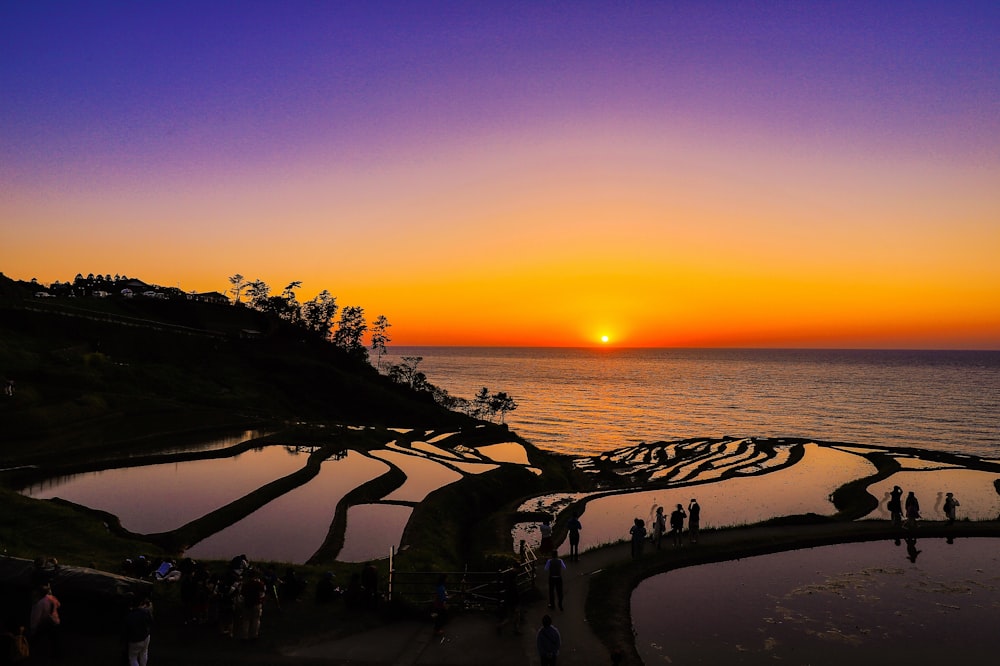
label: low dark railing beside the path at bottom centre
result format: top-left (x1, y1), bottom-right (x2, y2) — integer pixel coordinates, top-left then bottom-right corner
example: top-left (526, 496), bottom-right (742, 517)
top-left (387, 548), bottom-right (537, 610)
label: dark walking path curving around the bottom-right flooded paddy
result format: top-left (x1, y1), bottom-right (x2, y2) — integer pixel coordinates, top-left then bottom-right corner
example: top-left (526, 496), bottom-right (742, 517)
top-left (285, 521), bottom-right (1000, 666)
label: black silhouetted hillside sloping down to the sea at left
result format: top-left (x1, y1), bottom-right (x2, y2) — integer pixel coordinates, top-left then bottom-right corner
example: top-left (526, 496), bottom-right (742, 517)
top-left (0, 275), bottom-right (468, 465)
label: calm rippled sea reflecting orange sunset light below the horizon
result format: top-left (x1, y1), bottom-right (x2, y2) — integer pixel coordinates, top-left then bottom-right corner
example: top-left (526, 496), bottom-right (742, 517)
top-left (389, 347), bottom-right (1000, 457)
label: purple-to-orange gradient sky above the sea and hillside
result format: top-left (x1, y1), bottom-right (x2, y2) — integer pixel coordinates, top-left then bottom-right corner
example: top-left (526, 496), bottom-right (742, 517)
top-left (0, 0), bottom-right (1000, 349)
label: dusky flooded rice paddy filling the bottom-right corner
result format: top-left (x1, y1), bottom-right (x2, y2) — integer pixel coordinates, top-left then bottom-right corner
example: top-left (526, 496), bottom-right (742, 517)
top-left (631, 539), bottom-right (1000, 666)
